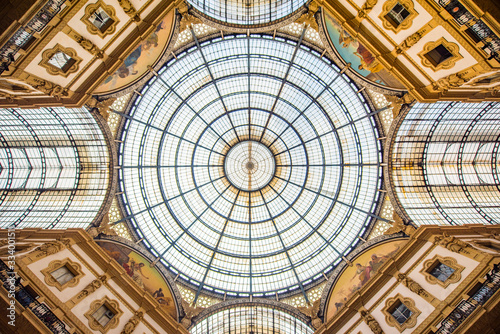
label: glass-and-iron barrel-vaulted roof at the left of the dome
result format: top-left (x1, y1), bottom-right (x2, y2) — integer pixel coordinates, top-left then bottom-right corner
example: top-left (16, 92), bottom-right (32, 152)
top-left (0, 108), bottom-right (109, 228)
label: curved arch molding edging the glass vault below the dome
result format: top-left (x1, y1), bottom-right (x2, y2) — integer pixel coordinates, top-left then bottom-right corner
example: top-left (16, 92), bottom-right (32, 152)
top-left (190, 298), bottom-right (312, 328)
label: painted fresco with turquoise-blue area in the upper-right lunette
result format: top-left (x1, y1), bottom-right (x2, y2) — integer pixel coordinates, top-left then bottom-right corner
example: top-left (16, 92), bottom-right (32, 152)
top-left (324, 13), bottom-right (405, 89)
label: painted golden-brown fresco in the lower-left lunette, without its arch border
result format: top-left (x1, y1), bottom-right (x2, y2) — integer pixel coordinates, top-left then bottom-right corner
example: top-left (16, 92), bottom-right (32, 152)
top-left (97, 241), bottom-right (177, 319)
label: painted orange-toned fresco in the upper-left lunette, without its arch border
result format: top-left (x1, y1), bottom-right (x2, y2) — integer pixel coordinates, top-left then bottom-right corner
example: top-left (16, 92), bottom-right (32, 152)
top-left (94, 11), bottom-right (174, 94)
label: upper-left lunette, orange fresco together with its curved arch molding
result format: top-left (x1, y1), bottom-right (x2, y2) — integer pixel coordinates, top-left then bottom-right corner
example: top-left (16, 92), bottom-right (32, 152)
top-left (94, 9), bottom-right (179, 97)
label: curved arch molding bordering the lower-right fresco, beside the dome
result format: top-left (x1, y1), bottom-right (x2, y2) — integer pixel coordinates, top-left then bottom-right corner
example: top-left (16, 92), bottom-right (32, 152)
top-left (318, 232), bottom-right (408, 322)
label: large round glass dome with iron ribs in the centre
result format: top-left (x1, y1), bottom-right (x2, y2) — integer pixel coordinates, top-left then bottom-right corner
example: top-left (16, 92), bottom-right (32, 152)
top-left (120, 35), bottom-right (381, 296)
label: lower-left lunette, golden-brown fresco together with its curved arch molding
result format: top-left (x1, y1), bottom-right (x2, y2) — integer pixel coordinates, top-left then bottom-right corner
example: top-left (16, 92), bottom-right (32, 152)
top-left (95, 235), bottom-right (183, 321)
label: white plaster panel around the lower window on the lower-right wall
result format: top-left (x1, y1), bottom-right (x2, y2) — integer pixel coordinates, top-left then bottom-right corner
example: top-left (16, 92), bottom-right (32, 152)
top-left (372, 284), bottom-right (434, 334)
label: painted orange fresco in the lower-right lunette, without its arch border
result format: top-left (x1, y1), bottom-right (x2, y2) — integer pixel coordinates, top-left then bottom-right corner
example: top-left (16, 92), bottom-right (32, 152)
top-left (326, 240), bottom-right (407, 320)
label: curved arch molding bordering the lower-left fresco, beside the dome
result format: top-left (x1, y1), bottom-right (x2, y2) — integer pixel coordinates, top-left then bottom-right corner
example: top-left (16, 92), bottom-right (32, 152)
top-left (94, 234), bottom-right (184, 321)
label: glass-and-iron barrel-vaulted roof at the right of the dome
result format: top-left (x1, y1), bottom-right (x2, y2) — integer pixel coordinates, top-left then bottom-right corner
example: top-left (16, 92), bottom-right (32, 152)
top-left (392, 102), bottom-right (500, 225)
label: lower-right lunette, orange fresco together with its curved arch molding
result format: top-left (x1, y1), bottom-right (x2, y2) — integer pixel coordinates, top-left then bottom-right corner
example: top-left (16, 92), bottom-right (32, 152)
top-left (322, 234), bottom-right (408, 323)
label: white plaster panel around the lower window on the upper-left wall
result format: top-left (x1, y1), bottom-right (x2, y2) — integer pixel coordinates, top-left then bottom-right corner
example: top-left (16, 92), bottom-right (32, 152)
top-left (25, 32), bottom-right (93, 87)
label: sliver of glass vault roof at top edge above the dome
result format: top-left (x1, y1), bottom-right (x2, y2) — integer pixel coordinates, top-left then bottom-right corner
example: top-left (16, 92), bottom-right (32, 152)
top-left (187, 0), bottom-right (307, 25)
